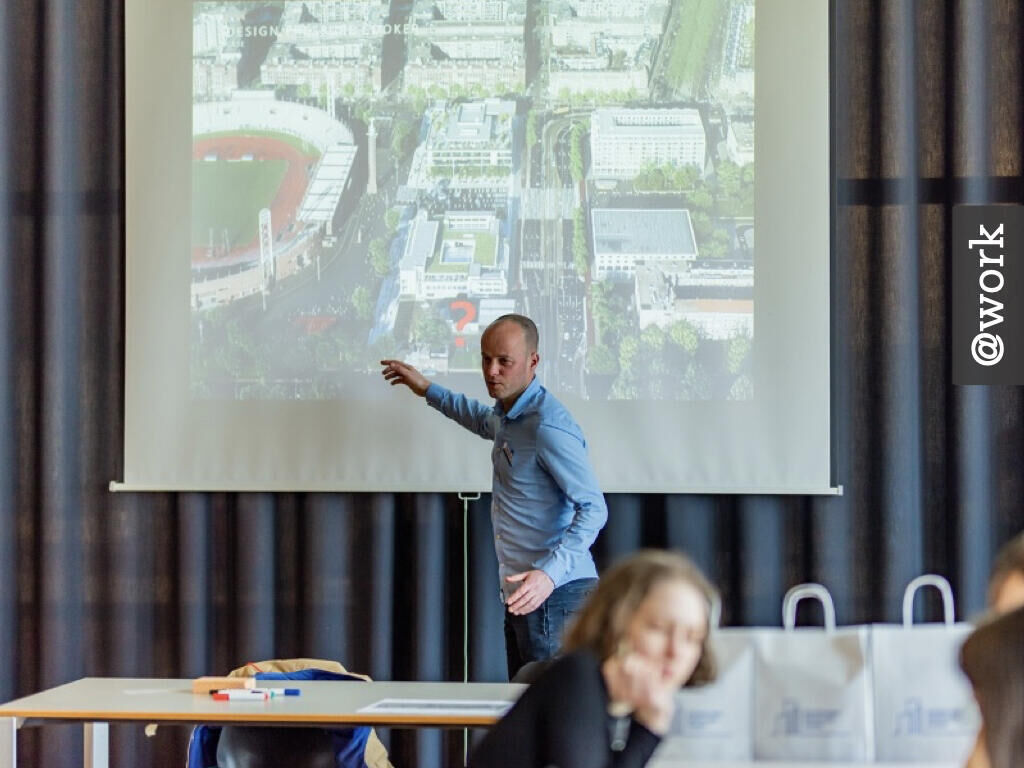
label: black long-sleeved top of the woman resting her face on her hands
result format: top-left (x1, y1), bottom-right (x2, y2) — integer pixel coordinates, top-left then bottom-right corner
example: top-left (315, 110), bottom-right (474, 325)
top-left (469, 651), bottom-right (660, 768)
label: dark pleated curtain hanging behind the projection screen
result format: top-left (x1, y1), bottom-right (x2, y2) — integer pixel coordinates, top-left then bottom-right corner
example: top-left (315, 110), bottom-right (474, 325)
top-left (0, 0), bottom-right (1024, 766)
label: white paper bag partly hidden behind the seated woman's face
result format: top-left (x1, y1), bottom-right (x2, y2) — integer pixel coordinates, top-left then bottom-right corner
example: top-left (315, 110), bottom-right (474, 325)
top-left (655, 629), bottom-right (754, 761)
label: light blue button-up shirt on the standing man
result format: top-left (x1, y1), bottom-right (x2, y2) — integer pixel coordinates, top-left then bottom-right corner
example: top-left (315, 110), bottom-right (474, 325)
top-left (426, 377), bottom-right (608, 598)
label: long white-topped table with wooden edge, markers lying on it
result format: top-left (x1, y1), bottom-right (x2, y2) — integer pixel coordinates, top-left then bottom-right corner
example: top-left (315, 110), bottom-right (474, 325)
top-left (0, 678), bottom-right (525, 768)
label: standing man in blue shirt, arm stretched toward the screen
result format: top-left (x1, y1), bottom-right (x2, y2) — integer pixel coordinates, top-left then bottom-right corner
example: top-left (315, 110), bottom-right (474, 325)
top-left (381, 314), bottom-right (608, 678)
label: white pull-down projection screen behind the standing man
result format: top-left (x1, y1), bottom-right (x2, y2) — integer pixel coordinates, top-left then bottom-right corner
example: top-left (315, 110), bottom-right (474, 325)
top-left (123, 0), bottom-right (833, 494)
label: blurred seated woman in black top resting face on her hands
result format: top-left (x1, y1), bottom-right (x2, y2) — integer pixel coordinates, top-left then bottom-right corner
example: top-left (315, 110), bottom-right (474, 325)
top-left (469, 550), bottom-right (715, 768)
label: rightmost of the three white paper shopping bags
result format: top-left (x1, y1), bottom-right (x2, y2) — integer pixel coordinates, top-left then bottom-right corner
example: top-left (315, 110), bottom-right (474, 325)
top-left (871, 574), bottom-right (979, 764)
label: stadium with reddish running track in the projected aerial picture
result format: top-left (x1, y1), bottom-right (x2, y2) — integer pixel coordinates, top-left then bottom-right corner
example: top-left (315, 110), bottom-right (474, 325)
top-left (191, 91), bottom-right (357, 309)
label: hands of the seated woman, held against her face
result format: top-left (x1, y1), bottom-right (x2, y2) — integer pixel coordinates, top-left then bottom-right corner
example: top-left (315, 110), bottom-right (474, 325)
top-left (601, 652), bottom-right (676, 735)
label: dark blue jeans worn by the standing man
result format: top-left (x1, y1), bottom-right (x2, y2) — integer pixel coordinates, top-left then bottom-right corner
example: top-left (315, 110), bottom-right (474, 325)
top-left (505, 579), bottom-right (597, 680)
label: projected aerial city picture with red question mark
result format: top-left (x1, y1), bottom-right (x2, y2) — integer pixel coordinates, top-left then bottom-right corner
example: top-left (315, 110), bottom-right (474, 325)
top-left (189, 0), bottom-right (755, 400)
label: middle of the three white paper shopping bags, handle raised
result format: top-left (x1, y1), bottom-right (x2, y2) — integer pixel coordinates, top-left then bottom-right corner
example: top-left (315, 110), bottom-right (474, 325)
top-left (754, 584), bottom-right (874, 762)
